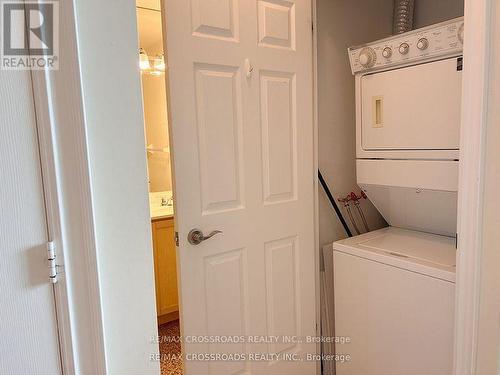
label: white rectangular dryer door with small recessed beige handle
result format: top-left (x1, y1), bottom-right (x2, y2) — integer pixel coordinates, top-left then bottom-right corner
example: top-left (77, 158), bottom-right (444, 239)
top-left (361, 58), bottom-right (462, 151)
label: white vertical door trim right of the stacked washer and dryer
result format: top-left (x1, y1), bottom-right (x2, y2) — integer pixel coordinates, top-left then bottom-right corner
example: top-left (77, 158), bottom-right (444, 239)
top-left (454, 0), bottom-right (491, 375)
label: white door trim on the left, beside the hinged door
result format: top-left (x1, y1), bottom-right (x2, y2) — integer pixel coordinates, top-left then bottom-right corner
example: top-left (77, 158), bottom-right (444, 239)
top-left (32, 0), bottom-right (106, 375)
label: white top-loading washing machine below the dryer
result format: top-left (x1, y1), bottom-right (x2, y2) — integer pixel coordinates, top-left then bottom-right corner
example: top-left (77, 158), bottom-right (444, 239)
top-left (333, 227), bottom-right (455, 375)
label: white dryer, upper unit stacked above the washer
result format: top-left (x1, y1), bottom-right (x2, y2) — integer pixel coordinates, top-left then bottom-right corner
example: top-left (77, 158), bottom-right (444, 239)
top-left (349, 18), bottom-right (463, 236)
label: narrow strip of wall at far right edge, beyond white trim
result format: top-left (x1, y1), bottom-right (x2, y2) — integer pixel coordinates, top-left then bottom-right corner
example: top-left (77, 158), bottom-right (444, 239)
top-left (476, 2), bottom-right (500, 375)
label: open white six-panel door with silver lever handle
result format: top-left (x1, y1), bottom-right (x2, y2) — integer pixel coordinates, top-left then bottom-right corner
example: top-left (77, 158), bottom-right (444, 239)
top-left (165, 0), bottom-right (316, 375)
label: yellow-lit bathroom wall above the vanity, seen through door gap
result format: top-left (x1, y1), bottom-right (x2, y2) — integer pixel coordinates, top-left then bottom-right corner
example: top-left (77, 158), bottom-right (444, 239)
top-left (137, 8), bottom-right (172, 192)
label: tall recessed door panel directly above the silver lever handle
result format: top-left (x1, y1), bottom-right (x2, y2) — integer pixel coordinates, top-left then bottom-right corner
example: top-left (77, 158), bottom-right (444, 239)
top-left (195, 64), bottom-right (244, 215)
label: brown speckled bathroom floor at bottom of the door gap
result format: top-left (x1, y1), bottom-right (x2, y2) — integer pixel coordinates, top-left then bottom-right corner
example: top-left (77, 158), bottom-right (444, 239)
top-left (158, 320), bottom-right (182, 375)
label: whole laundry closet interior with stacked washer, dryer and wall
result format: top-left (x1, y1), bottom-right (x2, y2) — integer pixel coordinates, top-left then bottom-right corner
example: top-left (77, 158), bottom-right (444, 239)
top-left (317, 0), bottom-right (466, 375)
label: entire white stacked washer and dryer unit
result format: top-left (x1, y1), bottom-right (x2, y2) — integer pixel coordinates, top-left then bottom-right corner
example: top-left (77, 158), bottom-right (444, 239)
top-left (332, 18), bottom-right (463, 375)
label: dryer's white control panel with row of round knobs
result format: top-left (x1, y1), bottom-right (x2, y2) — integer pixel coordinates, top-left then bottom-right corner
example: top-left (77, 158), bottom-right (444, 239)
top-left (348, 17), bottom-right (464, 74)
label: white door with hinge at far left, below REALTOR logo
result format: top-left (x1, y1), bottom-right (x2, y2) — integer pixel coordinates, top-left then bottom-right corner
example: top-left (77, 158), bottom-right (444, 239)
top-left (0, 70), bottom-right (61, 375)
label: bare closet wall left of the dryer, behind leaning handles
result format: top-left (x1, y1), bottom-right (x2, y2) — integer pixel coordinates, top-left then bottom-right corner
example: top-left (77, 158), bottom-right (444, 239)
top-left (317, 0), bottom-right (393, 245)
